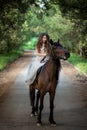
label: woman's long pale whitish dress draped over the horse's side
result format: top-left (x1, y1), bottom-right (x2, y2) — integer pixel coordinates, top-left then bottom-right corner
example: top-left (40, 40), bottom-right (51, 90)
top-left (26, 47), bottom-right (46, 85)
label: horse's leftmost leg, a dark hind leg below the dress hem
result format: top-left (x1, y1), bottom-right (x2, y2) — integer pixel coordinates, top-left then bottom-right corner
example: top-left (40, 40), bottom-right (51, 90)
top-left (29, 85), bottom-right (35, 116)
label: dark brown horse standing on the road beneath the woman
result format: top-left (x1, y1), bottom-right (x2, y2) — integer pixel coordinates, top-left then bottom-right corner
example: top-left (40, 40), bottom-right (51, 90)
top-left (29, 39), bottom-right (70, 126)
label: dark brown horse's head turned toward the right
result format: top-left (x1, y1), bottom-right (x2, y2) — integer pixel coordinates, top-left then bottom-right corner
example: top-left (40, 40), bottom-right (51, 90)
top-left (52, 40), bottom-right (70, 60)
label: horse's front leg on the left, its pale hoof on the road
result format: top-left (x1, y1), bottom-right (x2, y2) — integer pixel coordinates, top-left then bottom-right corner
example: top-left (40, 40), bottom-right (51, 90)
top-left (37, 95), bottom-right (44, 126)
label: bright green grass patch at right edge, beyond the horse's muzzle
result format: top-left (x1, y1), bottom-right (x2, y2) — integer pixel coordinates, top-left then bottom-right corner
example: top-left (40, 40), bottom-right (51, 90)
top-left (68, 53), bottom-right (87, 74)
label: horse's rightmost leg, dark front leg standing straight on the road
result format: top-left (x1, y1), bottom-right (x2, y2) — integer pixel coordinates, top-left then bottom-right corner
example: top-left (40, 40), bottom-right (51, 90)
top-left (49, 92), bottom-right (56, 126)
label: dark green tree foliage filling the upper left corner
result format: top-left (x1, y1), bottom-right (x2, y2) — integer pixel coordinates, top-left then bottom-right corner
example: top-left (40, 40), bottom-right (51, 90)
top-left (0, 0), bottom-right (34, 54)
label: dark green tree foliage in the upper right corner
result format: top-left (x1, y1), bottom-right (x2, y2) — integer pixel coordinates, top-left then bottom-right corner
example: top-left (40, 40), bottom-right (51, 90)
top-left (55, 0), bottom-right (87, 58)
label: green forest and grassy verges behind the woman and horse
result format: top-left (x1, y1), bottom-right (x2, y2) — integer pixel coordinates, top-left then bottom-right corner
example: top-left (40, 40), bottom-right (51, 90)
top-left (0, 0), bottom-right (87, 73)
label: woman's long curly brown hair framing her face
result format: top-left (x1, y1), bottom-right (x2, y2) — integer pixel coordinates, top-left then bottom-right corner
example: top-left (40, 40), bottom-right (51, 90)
top-left (36, 33), bottom-right (51, 53)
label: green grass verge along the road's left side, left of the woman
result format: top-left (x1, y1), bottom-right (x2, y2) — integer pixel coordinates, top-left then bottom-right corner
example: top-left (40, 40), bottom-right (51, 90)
top-left (0, 37), bottom-right (37, 70)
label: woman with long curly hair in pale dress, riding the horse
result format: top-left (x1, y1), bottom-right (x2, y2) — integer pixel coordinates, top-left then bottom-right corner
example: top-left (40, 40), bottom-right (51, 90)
top-left (26, 33), bottom-right (51, 85)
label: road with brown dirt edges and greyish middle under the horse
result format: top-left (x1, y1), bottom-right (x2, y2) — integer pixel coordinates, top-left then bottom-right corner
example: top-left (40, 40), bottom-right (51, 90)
top-left (0, 52), bottom-right (87, 130)
